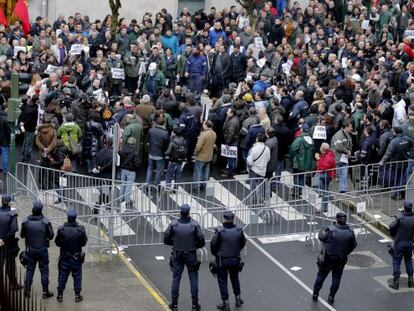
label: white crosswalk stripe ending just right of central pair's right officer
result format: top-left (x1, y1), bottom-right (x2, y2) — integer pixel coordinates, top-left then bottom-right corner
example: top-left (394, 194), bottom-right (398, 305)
top-left (207, 178), bottom-right (264, 225)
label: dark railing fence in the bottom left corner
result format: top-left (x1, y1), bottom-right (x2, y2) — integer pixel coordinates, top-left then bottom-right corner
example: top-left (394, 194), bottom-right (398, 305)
top-left (0, 246), bottom-right (46, 311)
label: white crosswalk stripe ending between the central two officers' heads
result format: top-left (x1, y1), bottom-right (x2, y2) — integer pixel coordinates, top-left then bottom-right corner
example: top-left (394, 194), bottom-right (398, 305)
top-left (169, 186), bottom-right (221, 228)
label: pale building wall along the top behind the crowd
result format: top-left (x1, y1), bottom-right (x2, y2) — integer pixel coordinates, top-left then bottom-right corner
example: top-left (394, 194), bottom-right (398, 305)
top-left (29, 0), bottom-right (309, 21)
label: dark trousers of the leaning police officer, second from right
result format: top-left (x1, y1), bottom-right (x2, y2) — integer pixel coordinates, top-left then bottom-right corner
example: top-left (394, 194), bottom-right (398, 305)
top-left (314, 254), bottom-right (348, 297)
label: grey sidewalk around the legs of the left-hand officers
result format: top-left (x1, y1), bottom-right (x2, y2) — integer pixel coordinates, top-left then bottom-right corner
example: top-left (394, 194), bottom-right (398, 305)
top-left (27, 246), bottom-right (166, 311)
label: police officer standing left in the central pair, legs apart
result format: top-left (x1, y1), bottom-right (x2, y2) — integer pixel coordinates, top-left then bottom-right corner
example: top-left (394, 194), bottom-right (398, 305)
top-left (164, 204), bottom-right (205, 311)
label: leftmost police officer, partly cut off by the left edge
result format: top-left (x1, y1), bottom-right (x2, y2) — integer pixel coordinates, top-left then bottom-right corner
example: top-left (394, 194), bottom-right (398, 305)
top-left (0, 194), bottom-right (21, 289)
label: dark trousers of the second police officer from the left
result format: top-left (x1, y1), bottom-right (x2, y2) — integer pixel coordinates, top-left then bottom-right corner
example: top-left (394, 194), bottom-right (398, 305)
top-left (24, 247), bottom-right (49, 292)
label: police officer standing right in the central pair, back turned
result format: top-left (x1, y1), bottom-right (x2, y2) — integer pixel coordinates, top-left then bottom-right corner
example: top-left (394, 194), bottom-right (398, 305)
top-left (210, 211), bottom-right (246, 311)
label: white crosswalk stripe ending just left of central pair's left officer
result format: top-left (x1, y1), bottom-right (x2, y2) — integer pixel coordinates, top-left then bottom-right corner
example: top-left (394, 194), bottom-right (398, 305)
top-left (131, 185), bottom-right (171, 232)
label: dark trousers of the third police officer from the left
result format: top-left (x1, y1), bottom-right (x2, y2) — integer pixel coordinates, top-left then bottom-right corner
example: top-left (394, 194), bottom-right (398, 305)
top-left (58, 256), bottom-right (82, 295)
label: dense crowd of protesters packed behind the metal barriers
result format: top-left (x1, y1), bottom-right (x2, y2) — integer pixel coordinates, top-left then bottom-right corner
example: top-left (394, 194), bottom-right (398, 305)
top-left (0, 0), bottom-right (414, 200)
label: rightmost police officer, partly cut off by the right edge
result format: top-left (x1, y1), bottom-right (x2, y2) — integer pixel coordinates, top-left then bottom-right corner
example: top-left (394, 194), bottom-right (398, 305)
top-left (389, 200), bottom-right (414, 290)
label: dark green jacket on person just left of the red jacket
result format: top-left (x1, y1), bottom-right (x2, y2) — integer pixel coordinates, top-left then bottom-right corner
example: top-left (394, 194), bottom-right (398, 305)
top-left (289, 133), bottom-right (316, 172)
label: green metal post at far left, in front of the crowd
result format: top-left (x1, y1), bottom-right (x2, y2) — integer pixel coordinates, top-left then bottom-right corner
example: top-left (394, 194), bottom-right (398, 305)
top-left (7, 72), bottom-right (20, 175)
